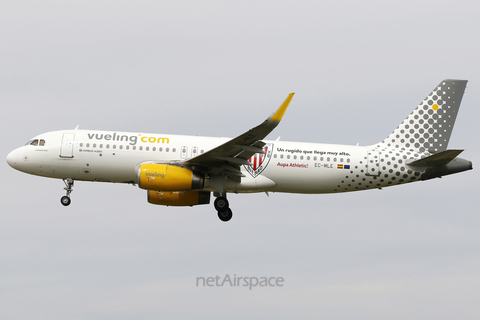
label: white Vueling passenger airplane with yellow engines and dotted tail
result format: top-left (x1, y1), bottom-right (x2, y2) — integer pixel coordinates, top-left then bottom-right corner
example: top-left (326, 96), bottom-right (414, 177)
top-left (6, 80), bottom-right (473, 221)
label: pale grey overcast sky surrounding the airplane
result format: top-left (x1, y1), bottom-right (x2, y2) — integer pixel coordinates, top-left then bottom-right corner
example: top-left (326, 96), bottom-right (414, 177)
top-left (0, 0), bottom-right (480, 320)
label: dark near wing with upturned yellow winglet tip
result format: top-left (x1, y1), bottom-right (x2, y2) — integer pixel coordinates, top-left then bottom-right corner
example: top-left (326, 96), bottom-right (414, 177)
top-left (182, 93), bottom-right (294, 177)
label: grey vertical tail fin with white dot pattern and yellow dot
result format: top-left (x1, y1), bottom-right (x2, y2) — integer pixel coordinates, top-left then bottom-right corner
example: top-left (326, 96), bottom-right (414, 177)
top-left (377, 79), bottom-right (467, 153)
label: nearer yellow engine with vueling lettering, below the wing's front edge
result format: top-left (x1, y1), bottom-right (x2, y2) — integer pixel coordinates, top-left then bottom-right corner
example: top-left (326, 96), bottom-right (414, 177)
top-left (137, 163), bottom-right (205, 191)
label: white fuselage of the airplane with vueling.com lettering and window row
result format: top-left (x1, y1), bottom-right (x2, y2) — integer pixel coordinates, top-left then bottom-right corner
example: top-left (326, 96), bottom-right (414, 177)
top-left (7, 130), bottom-right (423, 193)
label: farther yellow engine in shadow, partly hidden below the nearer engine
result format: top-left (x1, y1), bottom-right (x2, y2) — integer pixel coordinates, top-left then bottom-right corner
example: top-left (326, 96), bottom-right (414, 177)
top-left (147, 191), bottom-right (210, 206)
